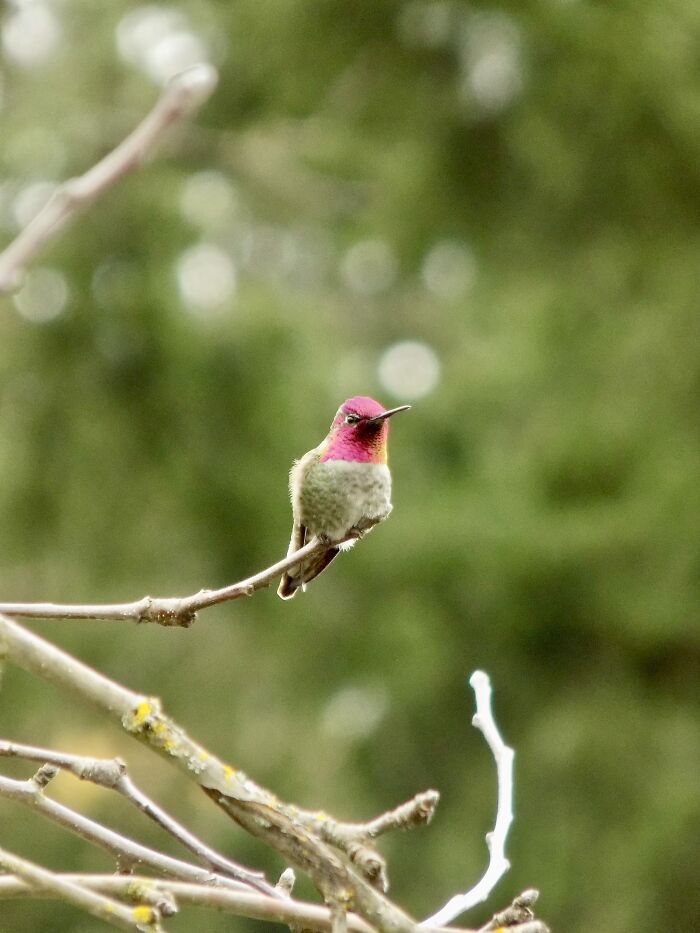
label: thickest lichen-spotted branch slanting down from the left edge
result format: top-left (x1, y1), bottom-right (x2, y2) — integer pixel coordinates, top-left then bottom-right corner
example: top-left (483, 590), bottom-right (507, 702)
top-left (0, 616), bottom-right (416, 933)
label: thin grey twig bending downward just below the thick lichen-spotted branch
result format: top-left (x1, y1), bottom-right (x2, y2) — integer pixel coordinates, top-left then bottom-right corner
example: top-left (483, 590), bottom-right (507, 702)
top-left (0, 740), bottom-right (275, 894)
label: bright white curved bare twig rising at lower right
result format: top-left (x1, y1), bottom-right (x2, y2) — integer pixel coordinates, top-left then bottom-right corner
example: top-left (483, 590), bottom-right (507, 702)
top-left (421, 671), bottom-right (515, 926)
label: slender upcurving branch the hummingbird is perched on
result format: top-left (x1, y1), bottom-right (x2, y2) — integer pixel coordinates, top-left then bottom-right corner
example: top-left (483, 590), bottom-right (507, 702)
top-left (0, 538), bottom-right (344, 627)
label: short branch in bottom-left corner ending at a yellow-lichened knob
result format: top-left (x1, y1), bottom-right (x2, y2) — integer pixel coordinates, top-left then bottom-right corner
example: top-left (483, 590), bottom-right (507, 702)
top-left (0, 849), bottom-right (160, 933)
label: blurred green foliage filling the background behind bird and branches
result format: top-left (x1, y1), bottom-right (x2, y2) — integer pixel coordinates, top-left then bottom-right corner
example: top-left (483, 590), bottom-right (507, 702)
top-left (0, 0), bottom-right (700, 933)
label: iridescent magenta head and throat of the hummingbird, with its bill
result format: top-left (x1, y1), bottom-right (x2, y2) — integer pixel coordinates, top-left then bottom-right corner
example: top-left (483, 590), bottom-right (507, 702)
top-left (321, 395), bottom-right (411, 463)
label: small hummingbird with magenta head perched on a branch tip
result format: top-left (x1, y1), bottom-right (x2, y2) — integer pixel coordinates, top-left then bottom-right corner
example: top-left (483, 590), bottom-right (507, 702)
top-left (277, 395), bottom-right (411, 599)
